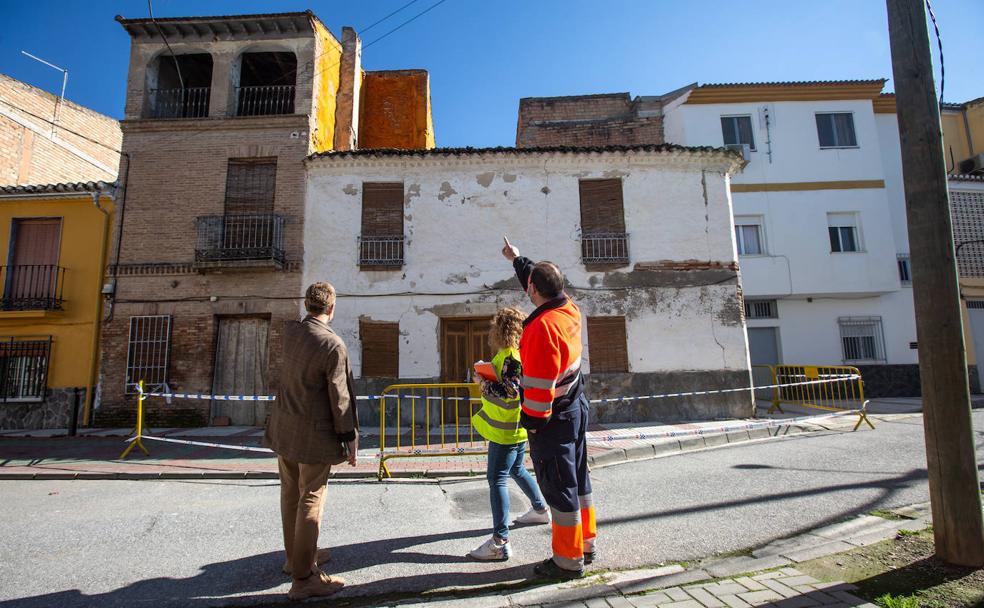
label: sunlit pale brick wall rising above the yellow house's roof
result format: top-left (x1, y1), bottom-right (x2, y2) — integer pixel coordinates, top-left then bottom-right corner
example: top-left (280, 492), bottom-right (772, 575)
top-left (0, 74), bottom-right (122, 185)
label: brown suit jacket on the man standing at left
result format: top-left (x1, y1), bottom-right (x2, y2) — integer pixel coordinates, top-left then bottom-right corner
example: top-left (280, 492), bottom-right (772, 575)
top-left (263, 316), bottom-right (359, 464)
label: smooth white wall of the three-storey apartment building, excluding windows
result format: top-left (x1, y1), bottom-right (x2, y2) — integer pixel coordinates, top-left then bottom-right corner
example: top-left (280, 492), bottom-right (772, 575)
top-left (664, 96), bottom-right (917, 365)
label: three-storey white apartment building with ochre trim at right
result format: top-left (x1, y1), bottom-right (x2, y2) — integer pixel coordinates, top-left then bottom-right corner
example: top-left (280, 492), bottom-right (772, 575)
top-left (662, 80), bottom-right (918, 396)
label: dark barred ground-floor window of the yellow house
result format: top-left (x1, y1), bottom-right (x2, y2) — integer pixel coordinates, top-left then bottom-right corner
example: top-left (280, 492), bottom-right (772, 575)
top-left (0, 336), bottom-right (51, 403)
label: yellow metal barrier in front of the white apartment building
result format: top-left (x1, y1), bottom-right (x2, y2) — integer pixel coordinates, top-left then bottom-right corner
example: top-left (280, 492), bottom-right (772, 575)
top-left (756, 365), bottom-right (875, 431)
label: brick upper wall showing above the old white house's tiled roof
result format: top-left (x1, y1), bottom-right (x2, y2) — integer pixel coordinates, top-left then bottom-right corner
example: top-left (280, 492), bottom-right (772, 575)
top-left (516, 93), bottom-right (664, 148)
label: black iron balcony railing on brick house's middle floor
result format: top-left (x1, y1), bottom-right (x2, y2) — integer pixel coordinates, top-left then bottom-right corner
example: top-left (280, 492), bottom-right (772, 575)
top-left (195, 213), bottom-right (286, 264)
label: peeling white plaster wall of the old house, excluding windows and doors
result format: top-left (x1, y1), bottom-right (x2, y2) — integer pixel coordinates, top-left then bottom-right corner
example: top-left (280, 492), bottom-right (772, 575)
top-left (303, 147), bottom-right (749, 404)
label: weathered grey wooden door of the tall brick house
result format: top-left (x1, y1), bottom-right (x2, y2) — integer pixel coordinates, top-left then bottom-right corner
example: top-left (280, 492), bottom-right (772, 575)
top-left (212, 317), bottom-right (270, 426)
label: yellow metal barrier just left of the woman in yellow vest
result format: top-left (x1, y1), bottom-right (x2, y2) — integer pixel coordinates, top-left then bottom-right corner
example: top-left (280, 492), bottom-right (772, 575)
top-left (377, 382), bottom-right (488, 480)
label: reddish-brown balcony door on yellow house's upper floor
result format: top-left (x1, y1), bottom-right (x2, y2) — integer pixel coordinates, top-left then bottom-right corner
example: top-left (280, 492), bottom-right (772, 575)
top-left (4, 218), bottom-right (61, 307)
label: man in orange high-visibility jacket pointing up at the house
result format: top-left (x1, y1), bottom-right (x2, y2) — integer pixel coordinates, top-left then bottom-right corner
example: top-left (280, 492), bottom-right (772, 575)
top-left (502, 234), bottom-right (597, 579)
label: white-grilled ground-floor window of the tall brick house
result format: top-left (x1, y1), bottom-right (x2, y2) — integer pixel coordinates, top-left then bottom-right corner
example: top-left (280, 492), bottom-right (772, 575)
top-left (126, 315), bottom-right (171, 394)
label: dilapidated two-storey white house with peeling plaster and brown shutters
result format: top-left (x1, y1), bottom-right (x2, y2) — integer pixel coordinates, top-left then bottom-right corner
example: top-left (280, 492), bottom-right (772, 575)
top-left (303, 145), bottom-right (748, 423)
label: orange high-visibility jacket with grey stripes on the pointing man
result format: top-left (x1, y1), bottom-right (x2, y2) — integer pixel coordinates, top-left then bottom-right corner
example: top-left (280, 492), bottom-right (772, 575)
top-left (519, 295), bottom-right (581, 418)
